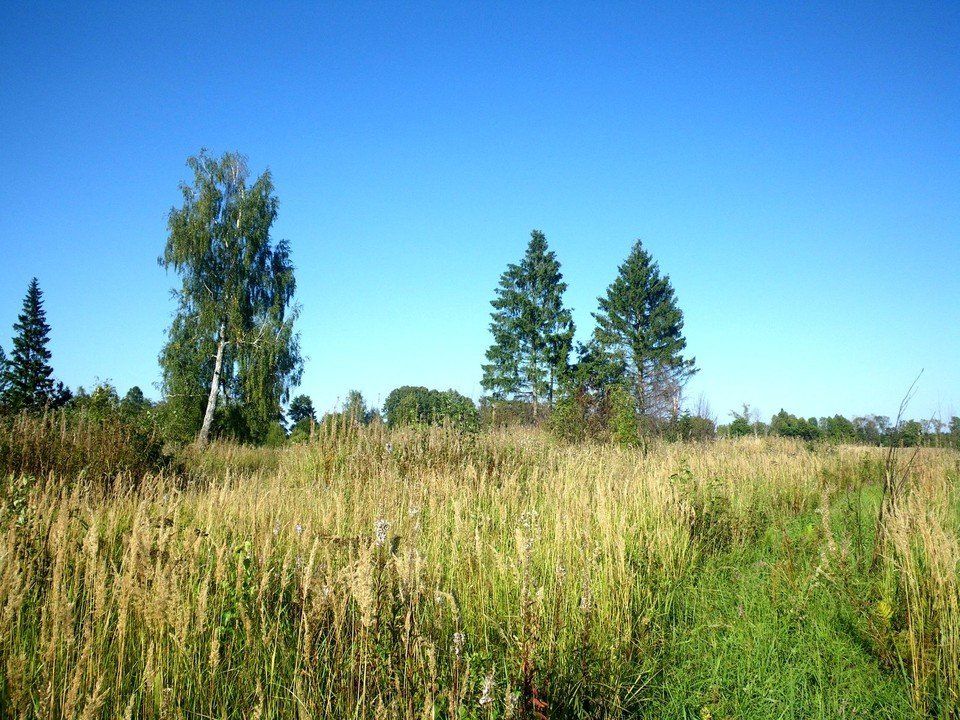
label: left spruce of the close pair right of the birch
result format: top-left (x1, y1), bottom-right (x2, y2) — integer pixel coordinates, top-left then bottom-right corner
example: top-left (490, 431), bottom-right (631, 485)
top-left (481, 230), bottom-right (574, 416)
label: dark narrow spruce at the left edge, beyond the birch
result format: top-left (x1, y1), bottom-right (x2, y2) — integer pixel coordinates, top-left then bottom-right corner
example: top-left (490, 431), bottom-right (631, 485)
top-left (3, 278), bottom-right (62, 411)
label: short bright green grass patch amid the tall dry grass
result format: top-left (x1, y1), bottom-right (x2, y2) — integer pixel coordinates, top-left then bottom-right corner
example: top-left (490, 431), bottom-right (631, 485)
top-left (646, 506), bottom-right (914, 719)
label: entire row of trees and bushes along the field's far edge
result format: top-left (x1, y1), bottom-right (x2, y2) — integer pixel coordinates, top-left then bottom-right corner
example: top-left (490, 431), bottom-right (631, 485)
top-left (0, 151), bottom-right (960, 445)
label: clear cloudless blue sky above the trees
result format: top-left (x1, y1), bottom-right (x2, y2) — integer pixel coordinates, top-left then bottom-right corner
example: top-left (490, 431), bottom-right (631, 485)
top-left (0, 2), bottom-right (960, 420)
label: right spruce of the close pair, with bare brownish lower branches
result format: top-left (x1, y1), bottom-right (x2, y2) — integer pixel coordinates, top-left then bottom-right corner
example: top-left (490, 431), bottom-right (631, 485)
top-left (594, 240), bottom-right (696, 418)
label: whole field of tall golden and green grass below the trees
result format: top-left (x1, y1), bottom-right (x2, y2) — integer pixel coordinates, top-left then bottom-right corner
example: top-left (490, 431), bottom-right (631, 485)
top-left (0, 427), bottom-right (960, 720)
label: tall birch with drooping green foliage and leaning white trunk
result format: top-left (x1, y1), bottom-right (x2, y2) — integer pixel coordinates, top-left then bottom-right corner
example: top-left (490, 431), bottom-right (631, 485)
top-left (160, 152), bottom-right (302, 442)
